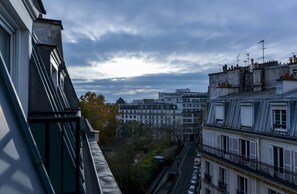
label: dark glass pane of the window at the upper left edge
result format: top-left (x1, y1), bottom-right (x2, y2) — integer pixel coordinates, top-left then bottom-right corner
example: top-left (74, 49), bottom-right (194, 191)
top-left (0, 26), bottom-right (10, 70)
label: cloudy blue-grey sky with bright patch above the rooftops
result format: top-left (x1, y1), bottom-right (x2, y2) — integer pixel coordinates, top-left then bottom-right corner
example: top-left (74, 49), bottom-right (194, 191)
top-left (43, 0), bottom-right (297, 102)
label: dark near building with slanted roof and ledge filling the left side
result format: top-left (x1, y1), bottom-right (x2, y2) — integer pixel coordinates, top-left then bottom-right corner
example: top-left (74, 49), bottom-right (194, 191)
top-left (0, 0), bottom-right (121, 194)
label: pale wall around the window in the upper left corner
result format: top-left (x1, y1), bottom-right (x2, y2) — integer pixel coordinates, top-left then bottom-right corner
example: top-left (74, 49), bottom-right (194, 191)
top-left (0, 0), bottom-right (39, 114)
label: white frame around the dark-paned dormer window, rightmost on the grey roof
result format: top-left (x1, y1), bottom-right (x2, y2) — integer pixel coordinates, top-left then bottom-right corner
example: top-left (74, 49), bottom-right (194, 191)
top-left (270, 103), bottom-right (290, 132)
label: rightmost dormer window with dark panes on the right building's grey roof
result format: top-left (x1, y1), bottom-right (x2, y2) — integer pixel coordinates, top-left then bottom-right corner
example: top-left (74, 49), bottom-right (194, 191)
top-left (271, 103), bottom-right (288, 132)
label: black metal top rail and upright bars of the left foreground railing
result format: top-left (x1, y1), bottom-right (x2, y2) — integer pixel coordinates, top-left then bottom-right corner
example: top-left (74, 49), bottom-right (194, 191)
top-left (28, 110), bottom-right (81, 194)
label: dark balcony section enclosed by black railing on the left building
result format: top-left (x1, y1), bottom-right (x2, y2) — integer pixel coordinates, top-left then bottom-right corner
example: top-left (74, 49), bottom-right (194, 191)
top-left (28, 109), bottom-right (83, 193)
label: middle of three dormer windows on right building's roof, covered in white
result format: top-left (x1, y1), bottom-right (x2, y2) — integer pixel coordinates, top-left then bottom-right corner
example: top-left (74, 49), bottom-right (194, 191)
top-left (240, 103), bottom-right (254, 127)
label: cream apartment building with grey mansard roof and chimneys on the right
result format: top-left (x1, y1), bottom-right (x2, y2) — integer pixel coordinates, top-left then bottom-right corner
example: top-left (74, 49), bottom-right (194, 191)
top-left (198, 56), bottom-right (297, 194)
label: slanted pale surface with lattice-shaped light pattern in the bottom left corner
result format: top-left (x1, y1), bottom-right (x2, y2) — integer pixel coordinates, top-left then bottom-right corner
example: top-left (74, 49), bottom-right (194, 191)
top-left (0, 66), bottom-right (45, 194)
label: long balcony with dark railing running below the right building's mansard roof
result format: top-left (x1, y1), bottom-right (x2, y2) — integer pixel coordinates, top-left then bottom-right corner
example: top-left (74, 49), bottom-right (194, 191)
top-left (198, 144), bottom-right (297, 189)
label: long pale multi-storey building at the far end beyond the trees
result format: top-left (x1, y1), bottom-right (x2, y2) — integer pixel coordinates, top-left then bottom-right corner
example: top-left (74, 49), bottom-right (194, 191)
top-left (117, 89), bottom-right (207, 141)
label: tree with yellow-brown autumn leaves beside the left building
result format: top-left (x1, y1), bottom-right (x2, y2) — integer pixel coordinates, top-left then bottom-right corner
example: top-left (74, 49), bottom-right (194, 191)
top-left (80, 92), bottom-right (118, 145)
